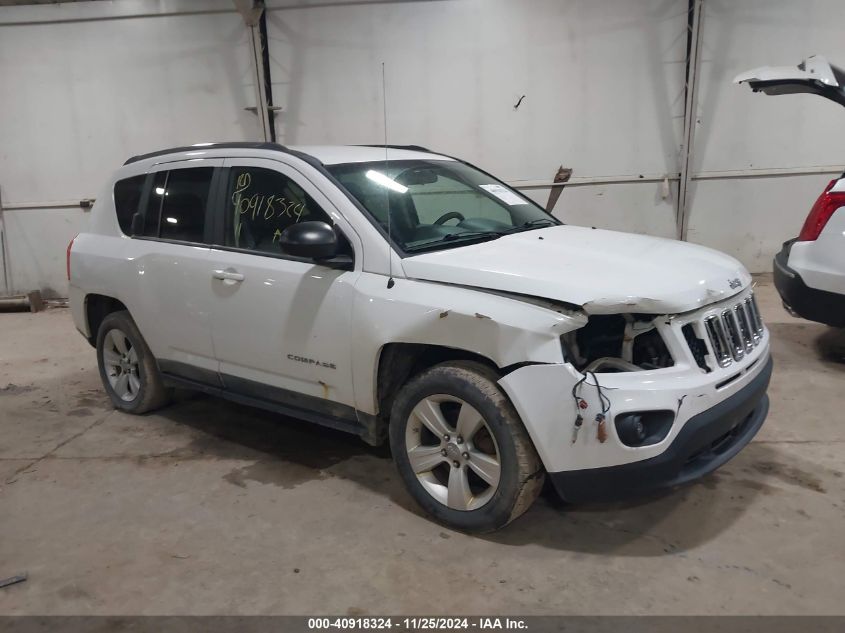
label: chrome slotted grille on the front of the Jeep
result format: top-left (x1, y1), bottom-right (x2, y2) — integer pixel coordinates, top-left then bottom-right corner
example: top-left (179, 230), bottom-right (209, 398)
top-left (704, 295), bottom-right (763, 367)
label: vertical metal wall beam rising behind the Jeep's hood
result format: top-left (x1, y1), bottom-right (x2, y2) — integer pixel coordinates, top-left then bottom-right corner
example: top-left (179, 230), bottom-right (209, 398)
top-left (676, 0), bottom-right (704, 240)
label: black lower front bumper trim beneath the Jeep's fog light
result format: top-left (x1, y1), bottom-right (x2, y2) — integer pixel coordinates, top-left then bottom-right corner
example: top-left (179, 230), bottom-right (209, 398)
top-left (548, 358), bottom-right (772, 502)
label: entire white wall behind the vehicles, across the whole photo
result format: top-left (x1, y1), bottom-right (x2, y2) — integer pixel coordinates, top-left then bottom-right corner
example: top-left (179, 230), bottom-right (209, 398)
top-left (0, 0), bottom-right (845, 295)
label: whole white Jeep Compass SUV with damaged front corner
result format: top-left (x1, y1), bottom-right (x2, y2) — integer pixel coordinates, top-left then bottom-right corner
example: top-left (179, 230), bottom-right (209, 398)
top-left (68, 143), bottom-right (771, 531)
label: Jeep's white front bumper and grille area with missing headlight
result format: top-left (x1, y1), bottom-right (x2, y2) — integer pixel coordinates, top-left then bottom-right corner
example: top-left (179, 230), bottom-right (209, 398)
top-left (499, 288), bottom-right (771, 481)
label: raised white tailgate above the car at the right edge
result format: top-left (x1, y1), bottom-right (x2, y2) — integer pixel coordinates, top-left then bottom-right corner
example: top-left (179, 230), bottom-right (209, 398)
top-left (734, 55), bottom-right (845, 106)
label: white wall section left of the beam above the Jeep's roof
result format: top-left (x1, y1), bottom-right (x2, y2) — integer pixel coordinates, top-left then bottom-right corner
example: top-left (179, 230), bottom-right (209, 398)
top-left (0, 0), bottom-right (258, 296)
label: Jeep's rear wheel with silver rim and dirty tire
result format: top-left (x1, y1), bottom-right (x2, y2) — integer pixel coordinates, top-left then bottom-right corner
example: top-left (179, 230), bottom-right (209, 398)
top-left (97, 310), bottom-right (170, 414)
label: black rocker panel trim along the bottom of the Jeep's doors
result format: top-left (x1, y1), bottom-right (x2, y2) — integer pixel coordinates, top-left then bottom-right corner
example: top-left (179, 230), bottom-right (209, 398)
top-left (158, 360), bottom-right (362, 439)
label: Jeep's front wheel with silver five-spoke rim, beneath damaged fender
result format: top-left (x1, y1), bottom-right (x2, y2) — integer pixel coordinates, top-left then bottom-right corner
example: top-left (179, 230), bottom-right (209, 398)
top-left (390, 362), bottom-right (545, 532)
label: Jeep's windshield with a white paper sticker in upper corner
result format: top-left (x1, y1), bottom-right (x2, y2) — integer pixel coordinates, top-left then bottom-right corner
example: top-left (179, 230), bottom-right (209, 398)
top-left (327, 160), bottom-right (560, 253)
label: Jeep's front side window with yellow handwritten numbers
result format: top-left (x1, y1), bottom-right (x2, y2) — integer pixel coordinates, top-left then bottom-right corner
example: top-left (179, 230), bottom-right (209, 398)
top-left (225, 167), bottom-right (334, 254)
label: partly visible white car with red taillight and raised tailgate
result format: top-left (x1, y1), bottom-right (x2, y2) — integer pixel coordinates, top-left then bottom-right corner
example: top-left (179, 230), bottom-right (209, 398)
top-left (734, 55), bottom-right (845, 327)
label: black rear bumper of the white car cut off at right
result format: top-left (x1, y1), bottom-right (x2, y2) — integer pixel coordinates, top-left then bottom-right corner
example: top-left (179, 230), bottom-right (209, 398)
top-left (773, 240), bottom-right (845, 327)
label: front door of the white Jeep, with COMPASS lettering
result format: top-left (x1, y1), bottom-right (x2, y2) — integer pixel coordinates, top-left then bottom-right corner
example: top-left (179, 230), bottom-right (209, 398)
top-left (207, 158), bottom-right (360, 417)
